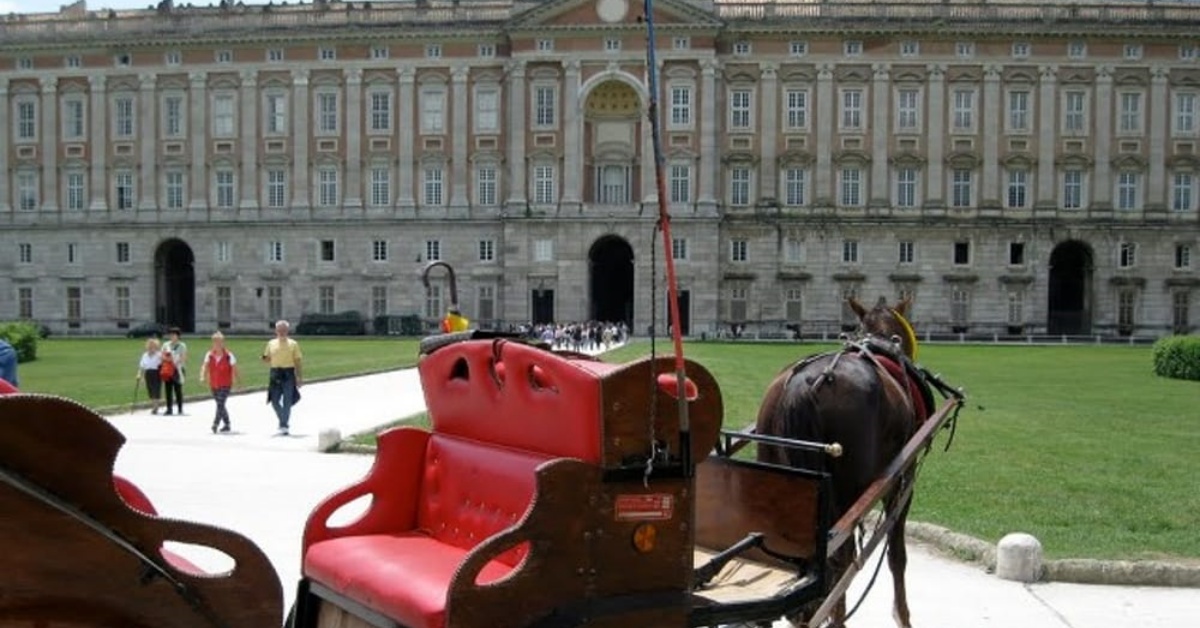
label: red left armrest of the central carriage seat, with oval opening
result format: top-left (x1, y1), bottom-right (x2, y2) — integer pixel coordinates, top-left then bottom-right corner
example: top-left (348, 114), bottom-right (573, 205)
top-left (301, 426), bottom-right (430, 555)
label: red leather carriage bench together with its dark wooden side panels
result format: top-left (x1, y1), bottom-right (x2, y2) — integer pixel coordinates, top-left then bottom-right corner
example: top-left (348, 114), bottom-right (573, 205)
top-left (296, 339), bottom-right (721, 628)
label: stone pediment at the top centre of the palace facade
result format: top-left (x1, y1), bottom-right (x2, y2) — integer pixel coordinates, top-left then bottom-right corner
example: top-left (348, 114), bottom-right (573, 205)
top-left (508, 0), bottom-right (721, 31)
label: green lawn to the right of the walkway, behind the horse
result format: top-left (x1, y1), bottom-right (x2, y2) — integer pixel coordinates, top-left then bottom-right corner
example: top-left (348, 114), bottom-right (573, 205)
top-left (606, 343), bottom-right (1200, 558)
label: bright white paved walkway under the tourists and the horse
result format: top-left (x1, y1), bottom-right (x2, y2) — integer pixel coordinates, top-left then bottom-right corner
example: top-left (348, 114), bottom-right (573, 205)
top-left (110, 345), bottom-right (1200, 628)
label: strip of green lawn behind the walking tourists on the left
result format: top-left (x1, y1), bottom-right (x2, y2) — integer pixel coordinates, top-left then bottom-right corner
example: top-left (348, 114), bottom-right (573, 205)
top-left (19, 336), bottom-right (418, 413)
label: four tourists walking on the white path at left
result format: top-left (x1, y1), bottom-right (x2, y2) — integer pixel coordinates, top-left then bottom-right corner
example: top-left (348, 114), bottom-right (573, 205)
top-left (136, 321), bottom-right (304, 436)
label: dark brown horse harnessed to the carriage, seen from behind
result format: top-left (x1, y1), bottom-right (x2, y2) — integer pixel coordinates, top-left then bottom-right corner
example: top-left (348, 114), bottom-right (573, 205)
top-left (756, 298), bottom-right (932, 628)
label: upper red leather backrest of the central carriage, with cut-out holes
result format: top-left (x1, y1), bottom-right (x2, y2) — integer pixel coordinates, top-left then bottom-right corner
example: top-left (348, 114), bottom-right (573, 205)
top-left (419, 340), bottom-right (608, 462)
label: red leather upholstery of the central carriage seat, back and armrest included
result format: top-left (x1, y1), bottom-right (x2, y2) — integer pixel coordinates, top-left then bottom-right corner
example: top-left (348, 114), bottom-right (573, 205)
top-left (300, 340), bottom-right (611, 628)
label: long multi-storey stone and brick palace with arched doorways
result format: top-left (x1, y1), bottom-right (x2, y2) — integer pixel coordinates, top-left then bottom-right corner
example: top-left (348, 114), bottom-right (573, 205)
top-left (0, 0), bottom-right (1200, 336)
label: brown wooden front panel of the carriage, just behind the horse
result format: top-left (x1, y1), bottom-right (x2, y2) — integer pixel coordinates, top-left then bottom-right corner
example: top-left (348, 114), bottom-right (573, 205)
top-left (696, 456), bottom-right (820, 567)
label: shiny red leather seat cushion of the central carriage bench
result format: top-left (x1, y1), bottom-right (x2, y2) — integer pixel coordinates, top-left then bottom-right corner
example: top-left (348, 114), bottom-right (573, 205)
top-left (305, 533), bottom-right (512, 628)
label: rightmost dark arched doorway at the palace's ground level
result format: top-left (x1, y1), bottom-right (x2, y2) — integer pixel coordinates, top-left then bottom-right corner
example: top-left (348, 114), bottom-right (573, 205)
top-left (1046, 240), bottom-right (1094, 335)
